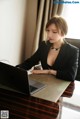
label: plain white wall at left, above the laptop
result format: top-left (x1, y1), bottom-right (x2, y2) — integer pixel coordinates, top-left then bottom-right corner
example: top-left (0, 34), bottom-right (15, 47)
top-left (0, 0), bottom-right (27, 65)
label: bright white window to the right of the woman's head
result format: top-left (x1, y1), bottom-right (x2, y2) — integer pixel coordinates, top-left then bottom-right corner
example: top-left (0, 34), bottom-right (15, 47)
top-left (62, 3), bottom-right (80, 39)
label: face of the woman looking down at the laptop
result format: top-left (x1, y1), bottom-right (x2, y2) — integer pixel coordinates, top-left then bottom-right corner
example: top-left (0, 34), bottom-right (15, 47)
top-left (46, 24), bottom-right (63, 43)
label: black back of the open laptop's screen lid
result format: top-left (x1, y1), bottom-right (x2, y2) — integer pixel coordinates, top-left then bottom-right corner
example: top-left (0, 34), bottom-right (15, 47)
top-left (0, 62), bottom-right (30, 95)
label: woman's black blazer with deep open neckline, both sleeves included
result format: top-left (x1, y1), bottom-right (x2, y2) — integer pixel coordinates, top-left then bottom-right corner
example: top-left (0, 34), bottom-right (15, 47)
top-left (17, 41), bottom-right (79, 81)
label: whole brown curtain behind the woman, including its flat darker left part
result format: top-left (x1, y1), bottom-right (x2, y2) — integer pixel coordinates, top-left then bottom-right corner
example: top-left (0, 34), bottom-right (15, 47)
top-left (26, 0), bottom-right (63, 57)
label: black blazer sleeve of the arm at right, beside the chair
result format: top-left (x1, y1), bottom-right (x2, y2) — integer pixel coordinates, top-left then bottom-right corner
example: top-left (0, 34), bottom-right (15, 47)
top-left (56, 49), bottom-right (79, 81)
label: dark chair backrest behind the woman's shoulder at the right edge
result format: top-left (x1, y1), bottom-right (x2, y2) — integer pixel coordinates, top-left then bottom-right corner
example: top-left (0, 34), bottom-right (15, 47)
top-left (66, 38), bottom-right (80, 81)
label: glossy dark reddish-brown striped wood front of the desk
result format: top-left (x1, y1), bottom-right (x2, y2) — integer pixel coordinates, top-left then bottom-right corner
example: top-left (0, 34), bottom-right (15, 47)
top-left (0, 89), bottom-right (59, 119)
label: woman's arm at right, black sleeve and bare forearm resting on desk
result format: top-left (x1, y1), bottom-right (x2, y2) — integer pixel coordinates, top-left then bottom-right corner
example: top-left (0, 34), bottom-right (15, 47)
top-left (32, 46), bottom-right (79, 81)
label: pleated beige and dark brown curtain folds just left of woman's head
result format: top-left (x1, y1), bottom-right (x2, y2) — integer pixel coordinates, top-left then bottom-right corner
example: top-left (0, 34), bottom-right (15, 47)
top-left (32, 0), bottom-right (63, 54)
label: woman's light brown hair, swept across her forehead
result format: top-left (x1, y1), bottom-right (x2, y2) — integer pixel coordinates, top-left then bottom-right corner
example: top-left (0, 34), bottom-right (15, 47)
top-left (46, 15), bottom-right (68, 35)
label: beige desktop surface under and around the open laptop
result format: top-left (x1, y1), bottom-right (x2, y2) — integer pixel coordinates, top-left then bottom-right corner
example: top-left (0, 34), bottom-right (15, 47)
top-left (29, 74), bottom-right (71, 102)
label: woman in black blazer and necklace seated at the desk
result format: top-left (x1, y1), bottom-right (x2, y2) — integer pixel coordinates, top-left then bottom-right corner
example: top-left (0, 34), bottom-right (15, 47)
top-left (17, 16), bottom-right (79, 81)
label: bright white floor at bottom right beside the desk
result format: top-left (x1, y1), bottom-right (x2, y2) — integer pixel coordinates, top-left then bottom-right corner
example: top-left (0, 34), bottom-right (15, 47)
top-left (61, 81), bottom-right (80, 119)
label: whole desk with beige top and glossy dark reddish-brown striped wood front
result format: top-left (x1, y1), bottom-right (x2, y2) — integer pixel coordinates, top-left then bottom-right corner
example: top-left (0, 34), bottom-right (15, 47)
top-left (0, 75), bottom-right (70, 119)
